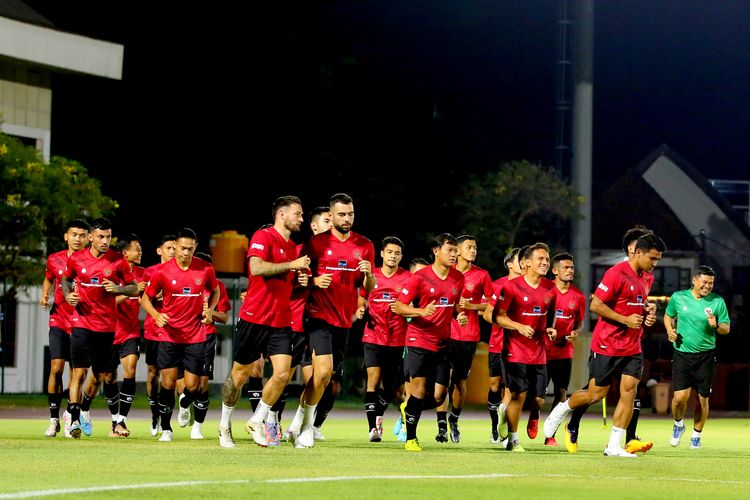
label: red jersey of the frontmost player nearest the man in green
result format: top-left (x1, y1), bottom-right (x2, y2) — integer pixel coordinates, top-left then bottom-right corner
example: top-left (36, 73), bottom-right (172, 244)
top-left (591, 262), bottom-right (654, 356)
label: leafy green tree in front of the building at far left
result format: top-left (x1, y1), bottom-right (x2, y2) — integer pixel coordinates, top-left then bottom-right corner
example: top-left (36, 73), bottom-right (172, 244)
top-left (0, 134), bottom-right (117, 296)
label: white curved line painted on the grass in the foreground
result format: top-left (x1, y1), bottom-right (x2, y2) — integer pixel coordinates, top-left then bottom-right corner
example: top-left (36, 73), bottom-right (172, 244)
top-left (0, 474), bottom-right (750, 499)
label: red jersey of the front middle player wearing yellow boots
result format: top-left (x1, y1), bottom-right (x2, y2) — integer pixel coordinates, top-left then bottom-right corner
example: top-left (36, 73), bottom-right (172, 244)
top-left (398, 266), bottom-right (464, 352)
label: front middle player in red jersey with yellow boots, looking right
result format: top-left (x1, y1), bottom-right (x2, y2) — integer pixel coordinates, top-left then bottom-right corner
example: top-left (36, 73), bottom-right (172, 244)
top-left (394, 233), bottom-right (468, 451)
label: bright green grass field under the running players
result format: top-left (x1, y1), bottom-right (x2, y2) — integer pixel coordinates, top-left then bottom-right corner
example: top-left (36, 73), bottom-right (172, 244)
top-left (0, 410), bottom-right (750, 500)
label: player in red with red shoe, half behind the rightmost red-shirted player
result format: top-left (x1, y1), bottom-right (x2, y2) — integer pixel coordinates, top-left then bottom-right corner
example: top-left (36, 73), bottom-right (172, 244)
top-left (544, 253), bottom-right (586, 446)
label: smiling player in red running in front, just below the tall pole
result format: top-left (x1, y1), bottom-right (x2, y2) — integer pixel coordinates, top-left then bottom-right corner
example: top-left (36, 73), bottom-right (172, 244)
top-left (492, 243), bottom-right (557, 452)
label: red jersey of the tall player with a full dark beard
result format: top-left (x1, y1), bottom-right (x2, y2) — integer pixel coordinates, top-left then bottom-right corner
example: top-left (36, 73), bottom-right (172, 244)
top-left (301, 231), bottom-right (375, 328)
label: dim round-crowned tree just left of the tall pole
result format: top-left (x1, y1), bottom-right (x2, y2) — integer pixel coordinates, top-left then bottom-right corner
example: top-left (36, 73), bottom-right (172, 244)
top-left (454, 160), bottom-right (583, 274)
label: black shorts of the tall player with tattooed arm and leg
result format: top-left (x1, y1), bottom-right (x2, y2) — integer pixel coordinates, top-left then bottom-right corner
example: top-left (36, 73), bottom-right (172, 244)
top-left (233, 319), bottom-right (292, 365)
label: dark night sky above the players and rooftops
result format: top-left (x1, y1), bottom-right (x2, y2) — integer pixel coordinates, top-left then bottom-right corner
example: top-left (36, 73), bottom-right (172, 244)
top-left (19, 0), bottom-right (750, 264)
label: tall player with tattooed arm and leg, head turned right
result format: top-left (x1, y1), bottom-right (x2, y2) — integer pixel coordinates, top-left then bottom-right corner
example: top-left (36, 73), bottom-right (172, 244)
top-left (219, 196), bottom-right (310, 448)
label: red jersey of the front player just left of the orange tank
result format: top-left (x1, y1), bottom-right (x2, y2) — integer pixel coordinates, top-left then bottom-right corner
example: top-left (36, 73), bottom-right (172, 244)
top-left (146, 257), bottom-right (219, 344)
